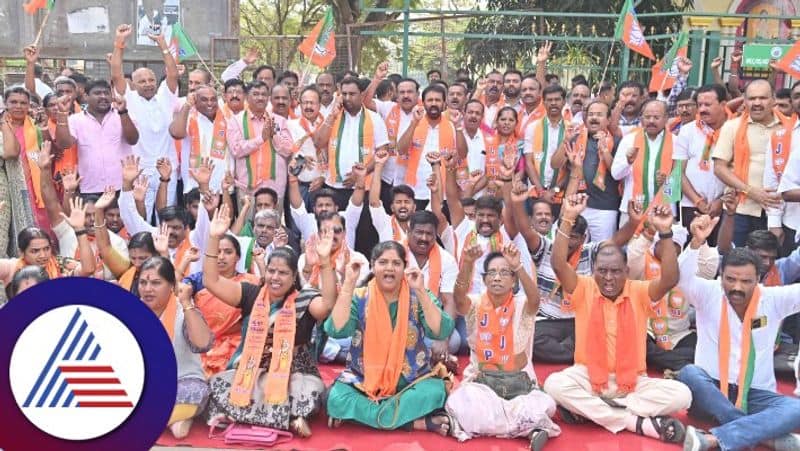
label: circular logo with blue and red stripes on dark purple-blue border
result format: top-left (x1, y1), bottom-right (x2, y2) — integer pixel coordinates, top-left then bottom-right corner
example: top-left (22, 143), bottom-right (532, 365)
top-left (0, 277), bottom-right (177, 451)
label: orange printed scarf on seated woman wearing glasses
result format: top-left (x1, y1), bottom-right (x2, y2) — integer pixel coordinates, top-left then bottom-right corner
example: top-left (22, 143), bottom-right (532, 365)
top-left (475, 292), bottom-right (518, 371)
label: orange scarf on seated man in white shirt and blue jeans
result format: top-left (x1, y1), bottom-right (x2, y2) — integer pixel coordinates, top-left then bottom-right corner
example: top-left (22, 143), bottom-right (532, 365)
top-left (719, 286), bottom-right (761, 413)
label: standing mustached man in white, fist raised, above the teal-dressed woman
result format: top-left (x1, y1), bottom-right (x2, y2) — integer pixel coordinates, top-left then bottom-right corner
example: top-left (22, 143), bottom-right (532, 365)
top-left (364, 62), bottom-right (419, 206)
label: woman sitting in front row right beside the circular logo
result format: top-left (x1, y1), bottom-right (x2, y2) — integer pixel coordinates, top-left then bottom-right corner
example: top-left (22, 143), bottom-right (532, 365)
top-left (139, 256), bottom-right (214, 438)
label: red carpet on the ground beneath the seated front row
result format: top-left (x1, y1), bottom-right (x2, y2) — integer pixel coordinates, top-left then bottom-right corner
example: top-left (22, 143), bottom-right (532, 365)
top-left (157, 359), bottom-right (794, 451)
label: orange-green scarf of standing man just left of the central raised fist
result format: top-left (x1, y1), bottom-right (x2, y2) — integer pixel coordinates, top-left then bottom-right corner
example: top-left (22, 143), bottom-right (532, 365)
top-left (328, 108), bottom-right (375, 186)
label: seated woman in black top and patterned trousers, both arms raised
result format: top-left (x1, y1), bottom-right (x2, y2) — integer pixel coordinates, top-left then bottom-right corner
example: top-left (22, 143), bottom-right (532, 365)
top-left (203, 205), bottom-right (336, 437)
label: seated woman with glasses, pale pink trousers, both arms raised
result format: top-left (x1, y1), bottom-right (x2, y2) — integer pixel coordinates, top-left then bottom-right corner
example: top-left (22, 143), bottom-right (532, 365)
top-left (446, 244), bottom-right (561, 451)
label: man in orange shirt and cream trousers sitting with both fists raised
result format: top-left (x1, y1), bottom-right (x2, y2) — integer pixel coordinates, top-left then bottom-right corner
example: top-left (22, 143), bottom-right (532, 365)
top-left (544, 194), bottom-right (692, 443)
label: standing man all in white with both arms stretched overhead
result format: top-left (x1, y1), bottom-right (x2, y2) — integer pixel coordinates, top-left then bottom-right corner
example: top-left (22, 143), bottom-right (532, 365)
top-left (111, 24), bottom-right (179, 221)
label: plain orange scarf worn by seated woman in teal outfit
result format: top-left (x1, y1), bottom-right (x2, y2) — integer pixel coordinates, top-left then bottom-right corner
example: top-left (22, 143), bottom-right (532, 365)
top-left (363, 279), bottom-right (411, 401)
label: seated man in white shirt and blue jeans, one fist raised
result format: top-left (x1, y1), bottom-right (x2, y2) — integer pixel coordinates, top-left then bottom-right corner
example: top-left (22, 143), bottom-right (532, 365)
top-left (678, 215), bottom-right (800, 451)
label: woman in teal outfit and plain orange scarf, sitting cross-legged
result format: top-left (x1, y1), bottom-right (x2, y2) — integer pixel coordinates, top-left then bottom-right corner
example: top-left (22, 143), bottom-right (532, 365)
top-left (318, 241), bottom-right (454, 435)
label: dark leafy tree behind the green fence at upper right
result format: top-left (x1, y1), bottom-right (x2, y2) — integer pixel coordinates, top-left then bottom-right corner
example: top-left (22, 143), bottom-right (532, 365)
top-left (459, 0), bottom-right (694, 81)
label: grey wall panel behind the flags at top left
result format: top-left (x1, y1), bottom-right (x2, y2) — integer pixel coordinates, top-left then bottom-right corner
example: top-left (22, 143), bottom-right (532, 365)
top-left (0, 0), bottom-right (238, 61)
